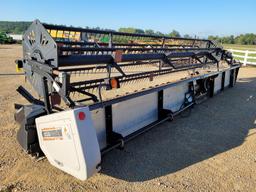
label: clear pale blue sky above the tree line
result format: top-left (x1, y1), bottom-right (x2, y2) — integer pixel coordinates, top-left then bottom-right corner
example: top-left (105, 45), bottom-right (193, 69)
top-left (0, 0), bottom-right (256, 37)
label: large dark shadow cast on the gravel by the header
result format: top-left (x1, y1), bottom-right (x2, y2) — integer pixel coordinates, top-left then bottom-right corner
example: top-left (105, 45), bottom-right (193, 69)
top-left (102, 75), bottom-right (256, 182)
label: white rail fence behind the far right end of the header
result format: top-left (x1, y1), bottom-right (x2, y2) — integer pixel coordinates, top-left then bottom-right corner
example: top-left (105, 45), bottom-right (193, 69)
top-left (229, 49), bottom-right (256, 66)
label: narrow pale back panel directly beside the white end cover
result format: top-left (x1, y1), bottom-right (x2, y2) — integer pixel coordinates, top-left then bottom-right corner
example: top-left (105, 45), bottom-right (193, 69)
top-left (91, 108), bottom-right (107, 149)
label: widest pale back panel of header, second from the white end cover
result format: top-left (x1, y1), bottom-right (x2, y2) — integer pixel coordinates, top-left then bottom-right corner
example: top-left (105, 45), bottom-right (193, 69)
top-left (112, 92), bottom-right (158, 136)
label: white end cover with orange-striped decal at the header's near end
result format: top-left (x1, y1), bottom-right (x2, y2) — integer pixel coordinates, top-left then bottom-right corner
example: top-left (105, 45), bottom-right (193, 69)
top-left (36, 107), bottom-right (101, 180)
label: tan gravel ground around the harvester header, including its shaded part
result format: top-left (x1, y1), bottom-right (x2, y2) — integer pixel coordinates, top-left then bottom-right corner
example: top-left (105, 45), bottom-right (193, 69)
top-left (0, 45), bottom-right (256, 192)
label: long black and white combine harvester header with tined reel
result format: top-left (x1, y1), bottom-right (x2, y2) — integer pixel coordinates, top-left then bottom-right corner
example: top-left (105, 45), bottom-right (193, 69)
top-left (15, 20), bottom-right (240, 180)
